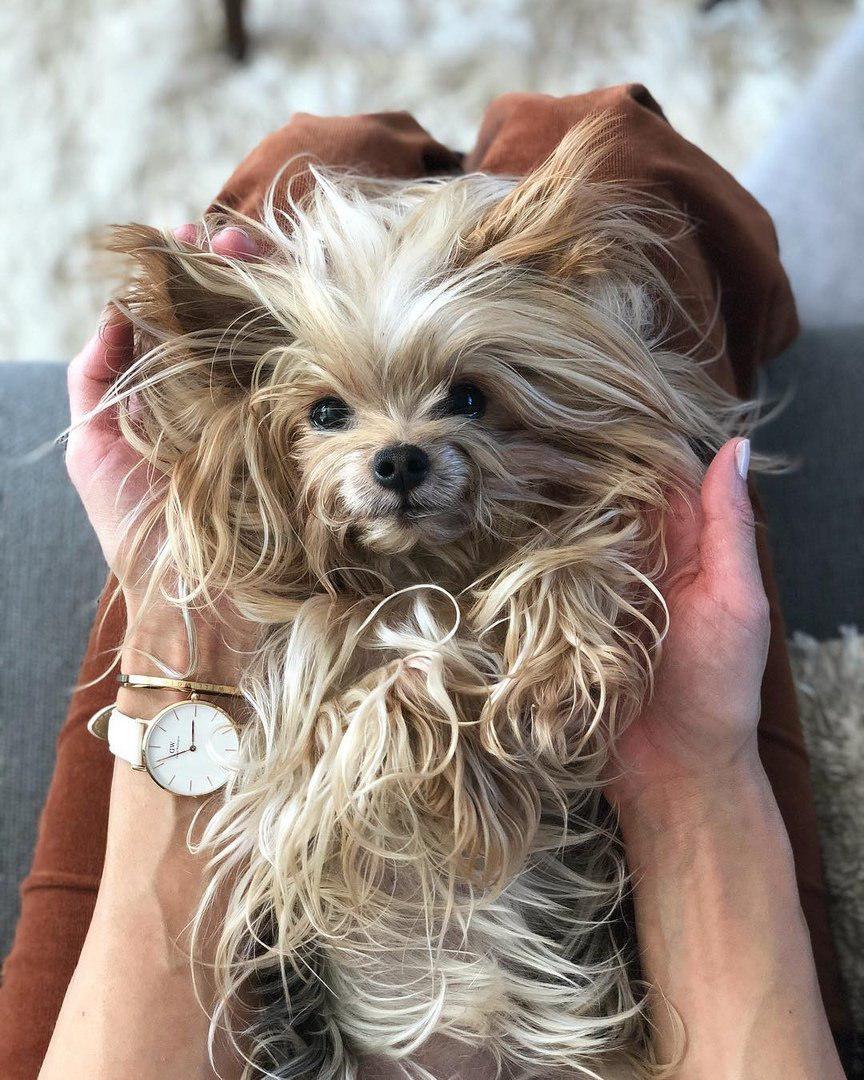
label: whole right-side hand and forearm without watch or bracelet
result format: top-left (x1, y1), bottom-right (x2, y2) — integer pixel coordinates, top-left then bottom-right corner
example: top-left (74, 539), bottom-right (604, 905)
top-left (606, 440), bottom-right (842, 1080)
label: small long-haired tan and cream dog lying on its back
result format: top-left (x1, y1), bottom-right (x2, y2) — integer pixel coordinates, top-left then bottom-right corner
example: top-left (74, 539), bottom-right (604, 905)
top-left (108, 124), bottom-right (750, 1080)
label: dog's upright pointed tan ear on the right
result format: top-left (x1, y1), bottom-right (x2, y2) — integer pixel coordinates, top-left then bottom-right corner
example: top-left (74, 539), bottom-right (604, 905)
top-left (458, 118), bottom-right (638, 279)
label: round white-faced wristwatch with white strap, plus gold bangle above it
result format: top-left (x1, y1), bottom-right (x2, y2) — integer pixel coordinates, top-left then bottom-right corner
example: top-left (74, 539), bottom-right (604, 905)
top-left (87, 676), bottom-right (240, 796)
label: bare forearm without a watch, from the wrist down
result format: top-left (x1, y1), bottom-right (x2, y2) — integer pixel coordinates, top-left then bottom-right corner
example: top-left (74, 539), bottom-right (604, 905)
top-left (621, 756), bottom-right (842, 1080)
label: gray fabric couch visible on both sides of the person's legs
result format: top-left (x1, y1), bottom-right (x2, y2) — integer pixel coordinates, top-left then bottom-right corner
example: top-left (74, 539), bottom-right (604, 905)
top-left (0, 327), bottom-right (864, 954)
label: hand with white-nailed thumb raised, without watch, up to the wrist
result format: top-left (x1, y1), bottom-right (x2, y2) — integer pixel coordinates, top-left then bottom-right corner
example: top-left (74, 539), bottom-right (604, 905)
top-left (606, 438), bottom-right (769, 813)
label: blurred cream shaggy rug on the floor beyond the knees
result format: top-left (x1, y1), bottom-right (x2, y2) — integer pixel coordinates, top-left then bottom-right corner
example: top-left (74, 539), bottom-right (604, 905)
top-left (0, 0), bottom-right (854, 360)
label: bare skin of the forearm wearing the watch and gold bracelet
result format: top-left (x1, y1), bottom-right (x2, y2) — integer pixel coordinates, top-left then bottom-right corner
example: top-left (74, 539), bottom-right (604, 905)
top-left (40, 632), bottom-right (248, 1080)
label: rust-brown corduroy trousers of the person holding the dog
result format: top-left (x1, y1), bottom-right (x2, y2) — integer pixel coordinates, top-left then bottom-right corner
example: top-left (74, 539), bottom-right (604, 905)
top-left (0, 85), bottom-right (847, 1080)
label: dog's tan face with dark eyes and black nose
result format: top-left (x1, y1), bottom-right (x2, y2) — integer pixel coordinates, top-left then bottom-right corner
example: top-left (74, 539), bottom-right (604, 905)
top-left (273, 291), bottom-right (561, 576)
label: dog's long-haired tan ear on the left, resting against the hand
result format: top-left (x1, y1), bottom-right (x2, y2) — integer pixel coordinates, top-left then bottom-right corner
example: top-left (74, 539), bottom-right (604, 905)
top-left (106, 226), bottom-right (301, 608)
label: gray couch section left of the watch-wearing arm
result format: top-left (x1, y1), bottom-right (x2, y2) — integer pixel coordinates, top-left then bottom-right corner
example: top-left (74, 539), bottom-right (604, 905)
top-left (0, 363), bottom-right (106, 955)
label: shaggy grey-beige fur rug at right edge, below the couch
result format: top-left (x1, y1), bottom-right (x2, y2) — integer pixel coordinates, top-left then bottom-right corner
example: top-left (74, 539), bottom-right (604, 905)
top-left (791, 629), bottom-right (864, 1041)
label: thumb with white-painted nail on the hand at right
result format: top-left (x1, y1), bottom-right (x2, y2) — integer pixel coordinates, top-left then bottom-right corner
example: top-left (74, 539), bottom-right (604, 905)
top-left (699, 438), bottom-right (766, 619)
